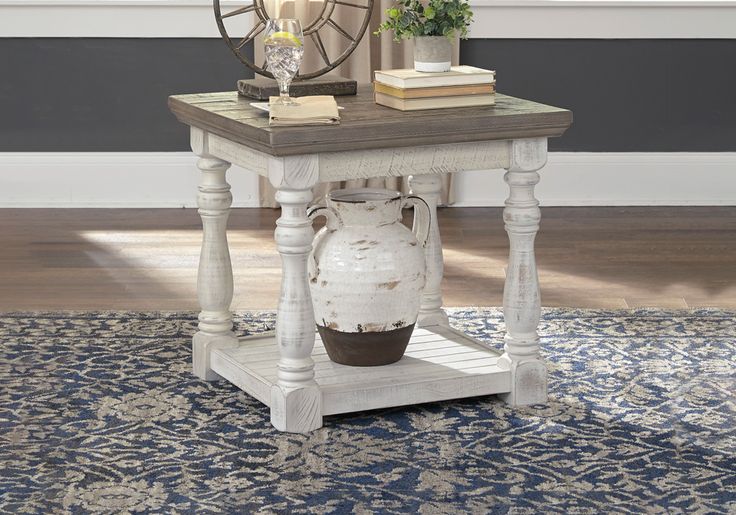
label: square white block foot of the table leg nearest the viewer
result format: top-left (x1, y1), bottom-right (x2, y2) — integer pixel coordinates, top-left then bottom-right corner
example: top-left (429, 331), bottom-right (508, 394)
top-left (271, 384), bottom-right (322, 433)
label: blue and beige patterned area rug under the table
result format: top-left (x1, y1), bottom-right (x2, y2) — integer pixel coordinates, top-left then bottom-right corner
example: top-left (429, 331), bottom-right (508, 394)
top-left (0, 308), bottom-right (736, 514)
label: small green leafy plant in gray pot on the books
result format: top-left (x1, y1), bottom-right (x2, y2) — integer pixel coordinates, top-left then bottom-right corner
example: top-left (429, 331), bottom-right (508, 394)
top-left (376, 0), bottom-right (473, 72)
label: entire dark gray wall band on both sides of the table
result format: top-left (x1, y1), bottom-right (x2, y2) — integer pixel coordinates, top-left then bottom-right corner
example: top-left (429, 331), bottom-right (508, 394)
top-left (0, 39), bottom-right (736, 152)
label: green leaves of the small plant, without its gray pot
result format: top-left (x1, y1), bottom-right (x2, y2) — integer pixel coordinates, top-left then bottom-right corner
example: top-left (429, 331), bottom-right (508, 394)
top-left (375, 0), bottom-right (473, 41)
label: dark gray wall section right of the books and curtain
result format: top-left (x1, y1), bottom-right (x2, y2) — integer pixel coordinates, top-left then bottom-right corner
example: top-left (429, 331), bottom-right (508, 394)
top-left (461, 40), bottom-right (736, 152)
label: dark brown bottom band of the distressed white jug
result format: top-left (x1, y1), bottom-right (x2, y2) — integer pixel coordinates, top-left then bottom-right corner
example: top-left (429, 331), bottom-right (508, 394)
top-left (317, 324), bottom-right (414, 367)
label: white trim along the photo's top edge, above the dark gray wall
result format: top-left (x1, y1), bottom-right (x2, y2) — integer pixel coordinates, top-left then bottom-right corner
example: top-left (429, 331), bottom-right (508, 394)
top-left (0, 0), bottom-right (736, 39)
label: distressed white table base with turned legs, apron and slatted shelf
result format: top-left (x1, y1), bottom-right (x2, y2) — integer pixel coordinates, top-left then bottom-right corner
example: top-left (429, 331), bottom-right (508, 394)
top-left (192, 129), bottom-right (547, 433)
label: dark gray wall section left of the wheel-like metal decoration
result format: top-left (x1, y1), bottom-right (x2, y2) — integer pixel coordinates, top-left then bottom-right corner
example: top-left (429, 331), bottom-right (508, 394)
top-left (0, 39), bottom-right (253, 152)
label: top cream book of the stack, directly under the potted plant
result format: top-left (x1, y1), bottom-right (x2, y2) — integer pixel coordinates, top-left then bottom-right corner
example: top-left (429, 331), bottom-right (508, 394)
top-left (375, 65), bottom-right (496, 89)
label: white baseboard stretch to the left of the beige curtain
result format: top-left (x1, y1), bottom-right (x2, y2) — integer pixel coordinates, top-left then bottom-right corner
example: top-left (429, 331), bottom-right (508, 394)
top-left (0, 152), bottom-right (258, 207)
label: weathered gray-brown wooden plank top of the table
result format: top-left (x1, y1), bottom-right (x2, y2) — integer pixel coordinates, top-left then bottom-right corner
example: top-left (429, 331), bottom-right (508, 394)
top-left (169, 86), bottom-right (572, 156)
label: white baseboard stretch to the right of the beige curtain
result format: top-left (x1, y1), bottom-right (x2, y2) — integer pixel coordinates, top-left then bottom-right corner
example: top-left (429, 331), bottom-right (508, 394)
top-left (455, 152), bottom-right (736, 206)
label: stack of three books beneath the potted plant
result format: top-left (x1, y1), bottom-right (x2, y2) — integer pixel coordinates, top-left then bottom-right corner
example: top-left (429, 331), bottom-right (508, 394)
top-left (373, 66), bottom-right (496, 111)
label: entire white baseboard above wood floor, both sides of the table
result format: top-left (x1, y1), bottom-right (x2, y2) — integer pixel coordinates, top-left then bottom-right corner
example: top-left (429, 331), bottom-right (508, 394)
top-left (0, 152), bottom-right (736, 208)
